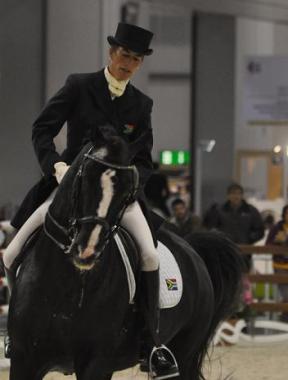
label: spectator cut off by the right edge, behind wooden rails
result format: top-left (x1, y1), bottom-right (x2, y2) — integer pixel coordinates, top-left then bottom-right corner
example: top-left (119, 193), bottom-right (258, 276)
top-left (266, 205), bottom-right (288, 322)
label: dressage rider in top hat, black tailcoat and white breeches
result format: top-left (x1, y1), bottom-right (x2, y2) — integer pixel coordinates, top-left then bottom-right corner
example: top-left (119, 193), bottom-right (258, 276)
top-left (3, 23), bottom-right (178, 379)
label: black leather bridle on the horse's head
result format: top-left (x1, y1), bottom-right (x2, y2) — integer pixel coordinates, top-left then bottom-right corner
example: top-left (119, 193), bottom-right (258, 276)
top-left (44, 146), bottom-right (139, 259)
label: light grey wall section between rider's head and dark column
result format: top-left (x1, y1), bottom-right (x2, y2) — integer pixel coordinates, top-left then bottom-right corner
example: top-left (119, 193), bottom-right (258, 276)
top-left (147, 3), bottom-right (192, 161)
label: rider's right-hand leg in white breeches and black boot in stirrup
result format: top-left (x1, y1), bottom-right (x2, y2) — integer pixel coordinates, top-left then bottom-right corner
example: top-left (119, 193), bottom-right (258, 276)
top-left (121, 202), bottom-right (178, 379)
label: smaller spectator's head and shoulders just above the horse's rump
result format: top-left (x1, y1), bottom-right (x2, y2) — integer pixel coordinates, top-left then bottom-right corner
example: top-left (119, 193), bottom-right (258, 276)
top-left (165, 198), bottom-right (202, 237)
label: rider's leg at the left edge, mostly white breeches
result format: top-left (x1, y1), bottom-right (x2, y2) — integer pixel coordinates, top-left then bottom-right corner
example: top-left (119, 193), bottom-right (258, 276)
top-left (3, 192), bottom-right (55, 282)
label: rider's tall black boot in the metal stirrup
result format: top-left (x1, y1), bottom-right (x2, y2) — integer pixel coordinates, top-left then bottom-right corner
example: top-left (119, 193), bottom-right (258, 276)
top-left (140, 270), bottom-right (179, 380)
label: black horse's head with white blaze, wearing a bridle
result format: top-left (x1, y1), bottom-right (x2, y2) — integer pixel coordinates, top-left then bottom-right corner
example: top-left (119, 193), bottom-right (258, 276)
top-left (51, 127), bottom-right (138, 270)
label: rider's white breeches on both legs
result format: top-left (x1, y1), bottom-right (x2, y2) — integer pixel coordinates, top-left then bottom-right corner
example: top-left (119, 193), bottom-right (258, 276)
top-left (3, 194), bottom-right (159, 272)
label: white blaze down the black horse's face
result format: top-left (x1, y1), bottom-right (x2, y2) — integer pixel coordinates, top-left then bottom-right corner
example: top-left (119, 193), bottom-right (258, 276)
top-left (80, 169), bottom-right (116, 259)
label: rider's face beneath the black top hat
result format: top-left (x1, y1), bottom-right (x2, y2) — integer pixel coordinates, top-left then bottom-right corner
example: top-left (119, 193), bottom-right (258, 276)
top-left (109, 46), bottom-right (143, 81)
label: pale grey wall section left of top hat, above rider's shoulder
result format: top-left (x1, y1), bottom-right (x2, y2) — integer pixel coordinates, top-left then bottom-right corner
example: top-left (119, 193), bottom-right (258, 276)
top-left (46, 0), bottom-right (102, 97)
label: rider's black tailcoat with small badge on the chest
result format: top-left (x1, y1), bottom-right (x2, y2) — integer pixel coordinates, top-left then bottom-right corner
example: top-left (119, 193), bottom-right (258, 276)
top-left (12, 70), bottom-right (153, 228)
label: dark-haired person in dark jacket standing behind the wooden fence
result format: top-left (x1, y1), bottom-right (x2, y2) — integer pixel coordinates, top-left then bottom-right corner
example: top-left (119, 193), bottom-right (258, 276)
top-left (203, 183), bottom-right (264, 268)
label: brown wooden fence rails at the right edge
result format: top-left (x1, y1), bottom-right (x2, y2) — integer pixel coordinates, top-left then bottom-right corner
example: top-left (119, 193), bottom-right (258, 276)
top-left (239, 245), bottom-right (288, 312)
